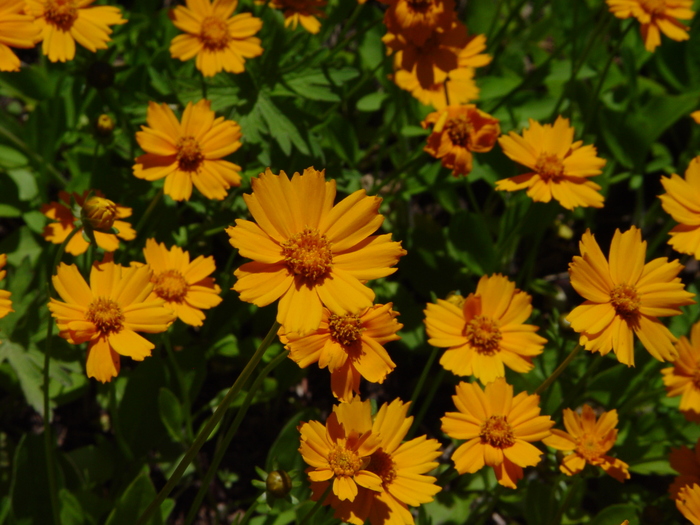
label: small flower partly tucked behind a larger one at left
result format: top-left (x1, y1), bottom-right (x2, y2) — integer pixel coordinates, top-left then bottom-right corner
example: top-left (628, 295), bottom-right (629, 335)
top-left (143, 239), bottom-right (221, 326)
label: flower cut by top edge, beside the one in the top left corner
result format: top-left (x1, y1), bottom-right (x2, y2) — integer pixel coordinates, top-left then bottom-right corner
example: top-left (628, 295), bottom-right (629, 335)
top-left (25, 0), bottom-right (127, 62)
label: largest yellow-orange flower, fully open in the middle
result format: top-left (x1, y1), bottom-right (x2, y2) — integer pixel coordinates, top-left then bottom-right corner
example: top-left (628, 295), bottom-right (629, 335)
top-left (226, 168), bottom-right (406, 336)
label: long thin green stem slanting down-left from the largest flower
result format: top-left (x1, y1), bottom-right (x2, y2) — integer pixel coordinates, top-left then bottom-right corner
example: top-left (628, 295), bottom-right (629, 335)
top-left (136, 321), bottom-right (280, 525)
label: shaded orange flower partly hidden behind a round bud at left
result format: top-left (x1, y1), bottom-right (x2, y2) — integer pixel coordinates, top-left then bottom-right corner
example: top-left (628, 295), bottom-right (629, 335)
top-left (41, 190), bottom-right (136, 255)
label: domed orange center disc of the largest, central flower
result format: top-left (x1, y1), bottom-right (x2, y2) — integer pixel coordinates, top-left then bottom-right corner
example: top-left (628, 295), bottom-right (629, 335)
top-left (281, 228), bottom-right (333, 284)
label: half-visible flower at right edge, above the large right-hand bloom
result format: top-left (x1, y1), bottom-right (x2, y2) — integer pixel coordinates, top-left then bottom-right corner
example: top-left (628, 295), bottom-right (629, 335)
top-left (659, 157), bottom-right (700, 259)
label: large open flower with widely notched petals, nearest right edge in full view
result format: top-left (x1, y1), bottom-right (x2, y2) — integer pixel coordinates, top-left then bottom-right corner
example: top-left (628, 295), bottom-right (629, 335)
top-left (566, 226), bottom-right (694, 366)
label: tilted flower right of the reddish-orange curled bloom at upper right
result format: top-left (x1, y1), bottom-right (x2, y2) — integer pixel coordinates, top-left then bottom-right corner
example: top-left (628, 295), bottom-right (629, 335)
top-left (496, 116), bottom-right (605, 210)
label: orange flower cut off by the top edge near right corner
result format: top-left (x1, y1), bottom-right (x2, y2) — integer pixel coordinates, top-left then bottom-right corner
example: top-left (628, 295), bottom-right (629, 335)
top-left (606, 0), bottom-right (695, 51)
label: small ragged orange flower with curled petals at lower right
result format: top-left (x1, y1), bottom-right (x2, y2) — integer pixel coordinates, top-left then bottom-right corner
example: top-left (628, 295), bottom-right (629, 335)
top-left (542, 405), bottom-right (630, 481)
